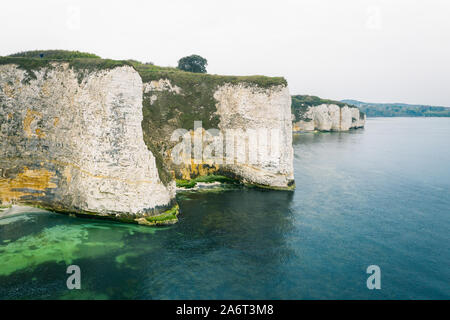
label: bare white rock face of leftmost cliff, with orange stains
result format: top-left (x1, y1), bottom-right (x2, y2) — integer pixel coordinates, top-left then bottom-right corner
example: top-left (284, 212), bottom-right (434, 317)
top-left (0, 63), bottom-right (175, 215)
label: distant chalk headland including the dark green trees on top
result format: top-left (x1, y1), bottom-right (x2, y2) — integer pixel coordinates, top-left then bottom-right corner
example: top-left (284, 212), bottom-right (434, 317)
top-left (292, 96), bottom-right (366, 131)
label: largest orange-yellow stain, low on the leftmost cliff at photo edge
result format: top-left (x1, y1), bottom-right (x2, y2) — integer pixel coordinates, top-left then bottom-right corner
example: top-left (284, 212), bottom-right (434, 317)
top-left (0, 167), bottom-right (57, 203)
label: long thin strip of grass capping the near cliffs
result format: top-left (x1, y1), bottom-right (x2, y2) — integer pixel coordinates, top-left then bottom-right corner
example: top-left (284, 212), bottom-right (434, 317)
top-left (0, 50), bottom-right (287, 88)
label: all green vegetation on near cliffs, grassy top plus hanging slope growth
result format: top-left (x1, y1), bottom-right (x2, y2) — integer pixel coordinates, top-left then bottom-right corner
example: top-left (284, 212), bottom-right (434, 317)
top-left (0, 50), bottom-right (287, 185)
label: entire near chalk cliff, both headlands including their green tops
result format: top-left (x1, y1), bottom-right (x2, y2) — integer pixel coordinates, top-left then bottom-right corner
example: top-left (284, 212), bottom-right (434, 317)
top-left (0, 54), bottom-right (294, 224)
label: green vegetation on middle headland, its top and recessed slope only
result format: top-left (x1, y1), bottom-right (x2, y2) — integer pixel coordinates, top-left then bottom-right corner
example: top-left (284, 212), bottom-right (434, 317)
top-left (129, 61), bottom-right (287, 183)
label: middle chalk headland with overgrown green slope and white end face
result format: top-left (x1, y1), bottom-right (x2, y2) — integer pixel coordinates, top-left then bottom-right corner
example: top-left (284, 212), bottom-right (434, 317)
top-left (137, 66), bottom-right (294, 190)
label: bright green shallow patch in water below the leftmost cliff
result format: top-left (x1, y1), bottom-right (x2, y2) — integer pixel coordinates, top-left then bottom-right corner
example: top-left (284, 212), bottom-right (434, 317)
top-left (0, 212), bottom-right (169, 277)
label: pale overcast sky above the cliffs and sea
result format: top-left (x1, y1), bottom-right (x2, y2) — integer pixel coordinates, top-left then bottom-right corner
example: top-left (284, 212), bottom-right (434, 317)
top-left (0, 0), bottom-right (450, 106)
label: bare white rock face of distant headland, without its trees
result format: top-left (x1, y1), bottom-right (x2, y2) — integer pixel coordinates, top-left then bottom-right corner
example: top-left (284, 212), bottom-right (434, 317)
top-left (293, 104), bottom-right (365, 131)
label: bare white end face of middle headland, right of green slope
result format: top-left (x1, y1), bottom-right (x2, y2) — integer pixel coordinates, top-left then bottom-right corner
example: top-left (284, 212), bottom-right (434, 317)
top-left (214, 84), bottom-right (294, 188)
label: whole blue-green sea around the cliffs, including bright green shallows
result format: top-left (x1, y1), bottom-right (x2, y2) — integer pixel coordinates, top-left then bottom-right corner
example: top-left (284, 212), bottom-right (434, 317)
top-left (0, 118), bottom-right (450, 299)
